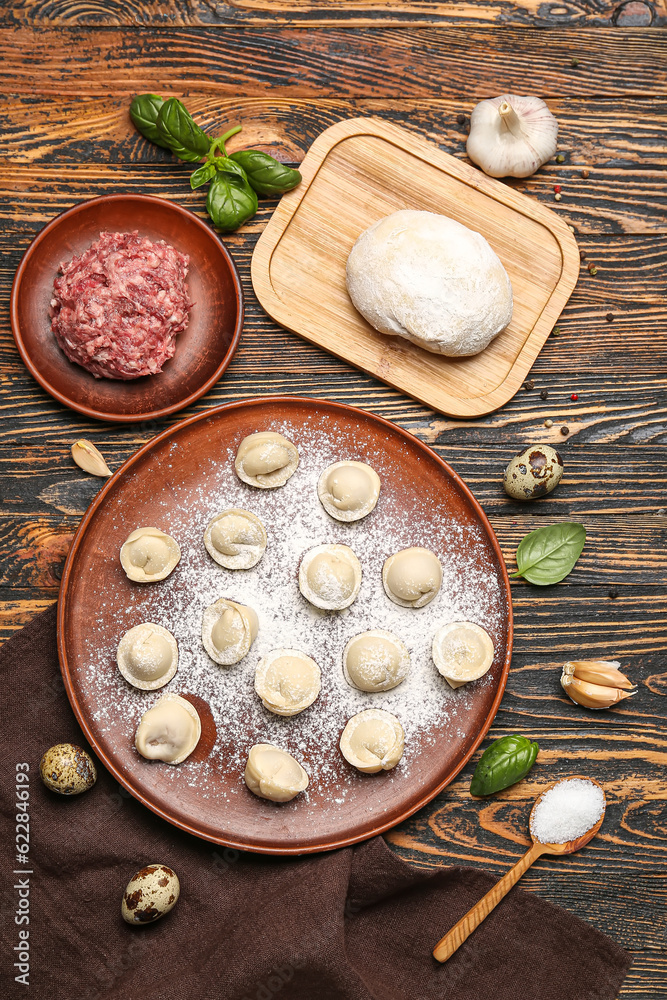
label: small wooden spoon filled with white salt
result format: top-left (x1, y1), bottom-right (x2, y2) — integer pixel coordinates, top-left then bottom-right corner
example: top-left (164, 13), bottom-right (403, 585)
top-left (433, 774), bottom-right (607, 962)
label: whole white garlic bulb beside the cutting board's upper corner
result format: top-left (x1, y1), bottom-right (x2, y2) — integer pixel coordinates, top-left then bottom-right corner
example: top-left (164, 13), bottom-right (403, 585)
top-left (467, 94), bottom-right (558, 177)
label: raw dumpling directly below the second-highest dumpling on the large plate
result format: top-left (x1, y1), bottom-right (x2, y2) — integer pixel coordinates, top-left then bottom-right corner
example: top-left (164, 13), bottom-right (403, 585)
top-left (299, 545), bottom-right (361, 611)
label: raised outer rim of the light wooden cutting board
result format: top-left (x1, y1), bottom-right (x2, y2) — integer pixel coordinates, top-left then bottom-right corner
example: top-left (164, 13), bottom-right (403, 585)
top-left (251, 117), bottom-right (580, 418)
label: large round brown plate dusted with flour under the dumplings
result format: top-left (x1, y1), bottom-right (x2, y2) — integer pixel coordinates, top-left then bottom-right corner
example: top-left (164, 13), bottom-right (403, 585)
top-left (58, 397), bottom-right (512, 854)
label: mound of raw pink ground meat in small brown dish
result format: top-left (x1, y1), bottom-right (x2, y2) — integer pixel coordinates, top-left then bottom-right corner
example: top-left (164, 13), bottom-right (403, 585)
top-left (51, 233), bottom-right (192, 379)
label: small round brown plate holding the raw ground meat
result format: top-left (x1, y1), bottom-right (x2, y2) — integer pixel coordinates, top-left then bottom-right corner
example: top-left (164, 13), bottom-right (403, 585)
top-left (11, 194), bottom-right (243, 422)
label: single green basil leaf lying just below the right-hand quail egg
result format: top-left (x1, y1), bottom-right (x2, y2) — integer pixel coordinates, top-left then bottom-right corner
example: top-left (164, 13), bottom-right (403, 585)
top-left (512, 521), bottom-right (586, 587)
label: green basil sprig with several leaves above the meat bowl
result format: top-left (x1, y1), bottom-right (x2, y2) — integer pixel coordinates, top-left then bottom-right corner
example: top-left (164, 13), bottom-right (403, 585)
top-left (130, 94), bottom-right (301, 233)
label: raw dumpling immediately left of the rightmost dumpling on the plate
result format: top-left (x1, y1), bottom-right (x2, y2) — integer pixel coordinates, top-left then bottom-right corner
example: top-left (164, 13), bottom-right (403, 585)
top-left (343, 629), bottom-right (410, 691)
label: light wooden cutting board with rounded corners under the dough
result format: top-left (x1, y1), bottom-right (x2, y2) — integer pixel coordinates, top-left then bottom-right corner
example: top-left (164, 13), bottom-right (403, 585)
top-left (252, 118), bottom-right (579, 417)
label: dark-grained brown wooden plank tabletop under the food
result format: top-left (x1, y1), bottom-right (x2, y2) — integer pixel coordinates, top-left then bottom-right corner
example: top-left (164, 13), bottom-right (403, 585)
top-left (0, 0), bottom-right (667, 1000)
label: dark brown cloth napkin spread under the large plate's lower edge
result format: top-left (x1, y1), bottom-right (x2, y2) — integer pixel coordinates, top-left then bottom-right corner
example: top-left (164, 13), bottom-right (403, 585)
top-left (0, 607), bottom-right (630, 1000)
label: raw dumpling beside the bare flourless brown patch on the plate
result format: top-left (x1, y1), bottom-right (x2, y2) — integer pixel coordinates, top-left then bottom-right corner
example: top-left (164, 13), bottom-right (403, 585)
top-left (134, 694), bottom-right (201, 764)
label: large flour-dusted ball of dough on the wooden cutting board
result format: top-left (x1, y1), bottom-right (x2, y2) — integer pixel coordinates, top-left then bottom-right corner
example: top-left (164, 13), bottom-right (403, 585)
top-left (347, 210), bottom-right (512, 357)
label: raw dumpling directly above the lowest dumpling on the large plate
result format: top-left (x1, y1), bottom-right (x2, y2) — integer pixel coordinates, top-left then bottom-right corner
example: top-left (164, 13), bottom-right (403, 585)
top-left (255, 649), bottom-right (321, 715)
